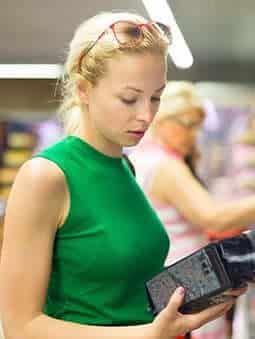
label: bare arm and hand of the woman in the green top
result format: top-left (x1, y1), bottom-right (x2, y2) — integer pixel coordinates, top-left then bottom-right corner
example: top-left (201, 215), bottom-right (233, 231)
top-left (0, 159), bottom-right (243, 339)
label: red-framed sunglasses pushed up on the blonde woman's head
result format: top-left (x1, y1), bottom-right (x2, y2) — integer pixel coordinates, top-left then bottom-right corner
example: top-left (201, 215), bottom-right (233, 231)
top-left (78, 21), bottom-right (172, 73)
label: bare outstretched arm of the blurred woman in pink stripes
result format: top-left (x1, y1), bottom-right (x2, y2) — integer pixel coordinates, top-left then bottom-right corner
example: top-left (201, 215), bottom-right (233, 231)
top-left (151, 159), bottom-right (255, 231)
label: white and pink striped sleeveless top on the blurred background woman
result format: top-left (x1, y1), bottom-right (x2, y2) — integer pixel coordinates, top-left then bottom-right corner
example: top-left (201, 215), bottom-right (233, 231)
top-left (130, 137), bottom-right (207, 266)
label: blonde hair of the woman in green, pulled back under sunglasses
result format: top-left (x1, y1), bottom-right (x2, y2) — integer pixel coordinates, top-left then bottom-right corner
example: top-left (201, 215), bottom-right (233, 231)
top-left (59, 12), bottom-right (169, 134)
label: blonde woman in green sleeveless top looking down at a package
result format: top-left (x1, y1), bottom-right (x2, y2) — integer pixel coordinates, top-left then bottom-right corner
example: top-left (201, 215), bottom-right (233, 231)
top-left (0, 13), bottom-right (244, 339)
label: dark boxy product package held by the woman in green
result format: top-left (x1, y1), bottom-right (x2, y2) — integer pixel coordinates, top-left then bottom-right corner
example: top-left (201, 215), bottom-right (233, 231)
top-left (146, 231), bottom-right (255, 314)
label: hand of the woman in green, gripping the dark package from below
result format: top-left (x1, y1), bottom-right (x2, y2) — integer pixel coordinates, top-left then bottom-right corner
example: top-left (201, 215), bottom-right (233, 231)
top-left (151, 287), bottom-right (247, 339)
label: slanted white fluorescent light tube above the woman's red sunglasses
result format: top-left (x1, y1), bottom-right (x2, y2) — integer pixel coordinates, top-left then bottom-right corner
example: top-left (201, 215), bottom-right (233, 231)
top-left (142, 0), bottom-right (194, 68)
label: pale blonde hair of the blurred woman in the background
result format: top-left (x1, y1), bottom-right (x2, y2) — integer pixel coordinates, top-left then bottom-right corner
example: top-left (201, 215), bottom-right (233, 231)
top-left (155, 81), bottom-right (205, 121)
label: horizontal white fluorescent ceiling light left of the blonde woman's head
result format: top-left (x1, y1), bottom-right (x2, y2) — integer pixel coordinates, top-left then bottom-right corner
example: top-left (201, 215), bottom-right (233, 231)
top-left (0, 64), bottom-right (63, 79)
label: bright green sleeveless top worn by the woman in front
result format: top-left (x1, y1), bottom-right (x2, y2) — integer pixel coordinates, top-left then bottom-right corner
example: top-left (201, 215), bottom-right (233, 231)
top-left (36, 136), bottom-right (169, 326)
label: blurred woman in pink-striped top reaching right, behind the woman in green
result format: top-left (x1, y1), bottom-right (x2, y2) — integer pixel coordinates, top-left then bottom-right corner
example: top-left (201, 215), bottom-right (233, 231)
top-left (130, 82), bottom-right (255, 339)
